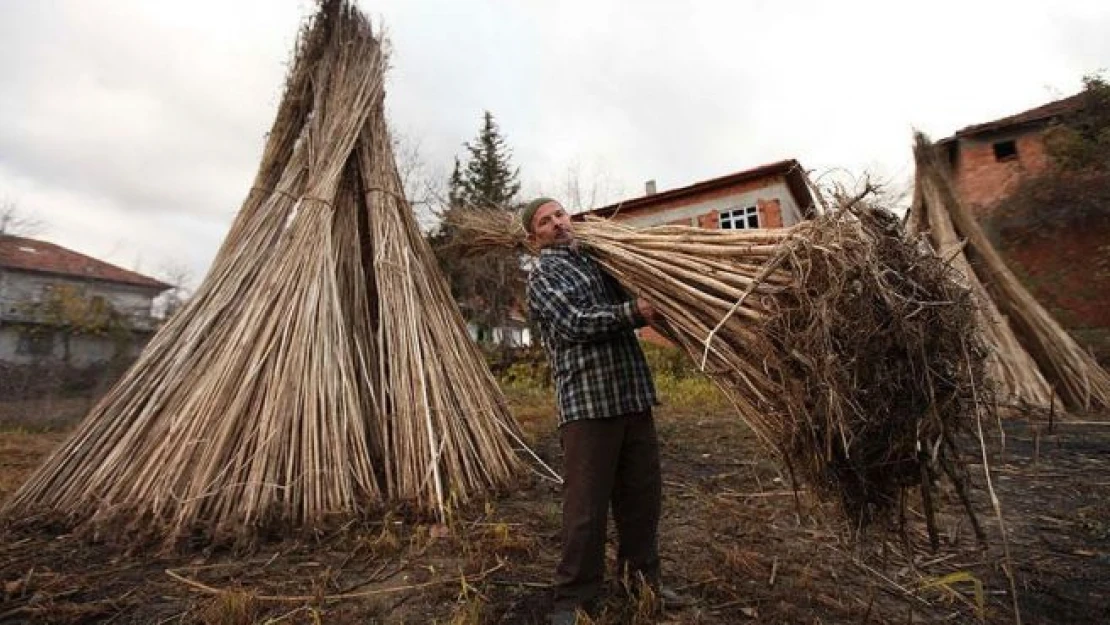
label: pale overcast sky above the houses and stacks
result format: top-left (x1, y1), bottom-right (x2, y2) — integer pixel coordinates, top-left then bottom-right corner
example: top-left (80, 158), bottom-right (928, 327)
top-left (0, 0), bottom-right (1110, 282)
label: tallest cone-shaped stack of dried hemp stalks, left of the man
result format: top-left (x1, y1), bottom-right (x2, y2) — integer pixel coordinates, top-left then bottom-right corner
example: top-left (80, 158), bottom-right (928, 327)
top-left (3, 0), bottom-right (532, 542)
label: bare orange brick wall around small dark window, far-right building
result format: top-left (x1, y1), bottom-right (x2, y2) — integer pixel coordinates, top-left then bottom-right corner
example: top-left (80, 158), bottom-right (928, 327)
top-left (956, 129), bottom-right (1048, 215)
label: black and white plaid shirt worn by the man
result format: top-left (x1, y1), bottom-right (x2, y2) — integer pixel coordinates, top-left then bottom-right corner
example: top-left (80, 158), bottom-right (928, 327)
top-left (528, 246), bottom-right (656, 425)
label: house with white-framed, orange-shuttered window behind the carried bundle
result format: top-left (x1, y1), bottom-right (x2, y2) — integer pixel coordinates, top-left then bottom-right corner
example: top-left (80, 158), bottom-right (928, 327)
top-left (591, 159), bottom-right (815, 229)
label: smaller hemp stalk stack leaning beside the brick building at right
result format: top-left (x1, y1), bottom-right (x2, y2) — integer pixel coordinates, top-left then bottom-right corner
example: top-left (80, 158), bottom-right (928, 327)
top-left (908, 133), bottom-right (1110, 411)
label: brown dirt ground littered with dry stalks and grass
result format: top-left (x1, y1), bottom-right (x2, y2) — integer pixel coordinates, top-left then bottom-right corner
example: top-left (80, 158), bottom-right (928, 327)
top-left (0, 395), bottom-right (1110, 625)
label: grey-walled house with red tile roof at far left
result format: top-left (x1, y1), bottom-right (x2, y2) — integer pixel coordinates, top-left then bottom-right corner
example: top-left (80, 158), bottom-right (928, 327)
top-left (0, 234), bottom-right (171, 367)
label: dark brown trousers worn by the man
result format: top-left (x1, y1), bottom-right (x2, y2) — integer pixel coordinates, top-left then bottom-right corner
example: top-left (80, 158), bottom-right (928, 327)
top-left (555, 411), bottom-right (663, 608)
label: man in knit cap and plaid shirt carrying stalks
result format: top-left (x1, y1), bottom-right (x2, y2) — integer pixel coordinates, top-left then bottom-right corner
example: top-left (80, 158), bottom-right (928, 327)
top-left (521, 198), bottom-right (682, 625)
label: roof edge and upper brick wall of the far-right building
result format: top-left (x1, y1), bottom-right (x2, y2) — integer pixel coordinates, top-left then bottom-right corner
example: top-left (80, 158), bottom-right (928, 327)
top-left (938, 93), bottom-right (1082, 215)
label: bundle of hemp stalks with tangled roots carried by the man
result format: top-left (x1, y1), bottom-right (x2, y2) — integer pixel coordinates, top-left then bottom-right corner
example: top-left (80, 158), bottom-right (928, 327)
top-left (455, 204), bottom-right (985, 541)
